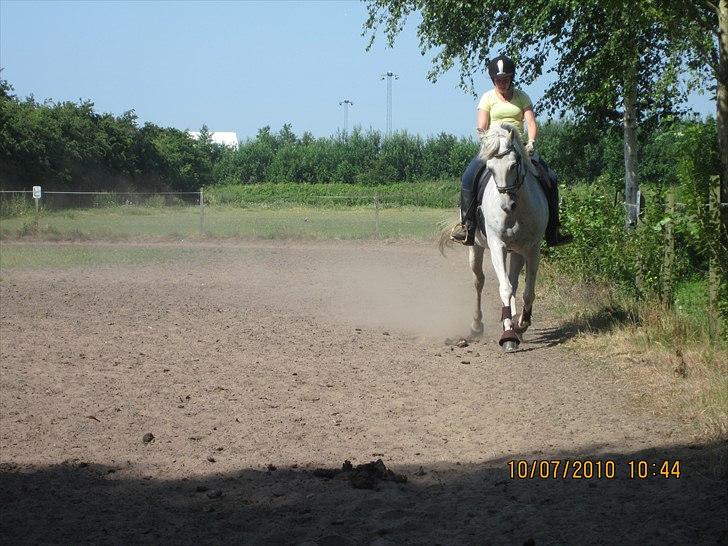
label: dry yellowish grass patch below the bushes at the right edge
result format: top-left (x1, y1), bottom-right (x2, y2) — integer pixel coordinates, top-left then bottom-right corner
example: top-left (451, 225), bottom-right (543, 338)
top-left (537, 260), bottom-right (728, 438)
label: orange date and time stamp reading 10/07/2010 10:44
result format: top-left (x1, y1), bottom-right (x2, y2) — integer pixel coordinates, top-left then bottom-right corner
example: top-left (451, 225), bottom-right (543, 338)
top-left (507, 459), bottom-right (682, 480)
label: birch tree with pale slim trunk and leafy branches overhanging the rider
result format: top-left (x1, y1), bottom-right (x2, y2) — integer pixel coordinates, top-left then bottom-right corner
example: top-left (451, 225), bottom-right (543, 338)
top-left (364, 0), bottom-right (716, 225)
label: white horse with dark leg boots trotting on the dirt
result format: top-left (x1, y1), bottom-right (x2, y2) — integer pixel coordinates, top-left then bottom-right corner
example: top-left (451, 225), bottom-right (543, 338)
top-left (456, 124), bottom-right (548, 352)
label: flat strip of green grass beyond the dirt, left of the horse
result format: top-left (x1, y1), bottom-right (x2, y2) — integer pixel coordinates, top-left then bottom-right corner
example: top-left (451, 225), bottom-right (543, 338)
top-left (0, 206), bottom-right (454, 240)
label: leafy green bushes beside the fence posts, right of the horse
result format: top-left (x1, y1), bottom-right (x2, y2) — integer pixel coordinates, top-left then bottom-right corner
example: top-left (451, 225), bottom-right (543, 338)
top-left (546, 177), bottom-right (728, 330)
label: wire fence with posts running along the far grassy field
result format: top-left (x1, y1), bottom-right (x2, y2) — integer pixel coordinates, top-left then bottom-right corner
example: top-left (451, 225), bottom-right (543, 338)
top-left (0, 191), bottom-right (455, 239)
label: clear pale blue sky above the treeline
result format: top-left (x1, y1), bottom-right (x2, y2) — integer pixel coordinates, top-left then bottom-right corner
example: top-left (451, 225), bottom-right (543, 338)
top-left (0, 0), bottom-right (715, 139)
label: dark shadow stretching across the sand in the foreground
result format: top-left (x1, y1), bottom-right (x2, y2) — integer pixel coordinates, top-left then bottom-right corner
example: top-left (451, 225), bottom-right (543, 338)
top-left (0, 440), bottom-right (728, 545)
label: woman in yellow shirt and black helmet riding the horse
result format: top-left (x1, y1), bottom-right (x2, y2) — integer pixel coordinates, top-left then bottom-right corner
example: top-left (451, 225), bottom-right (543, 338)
top-left (450, 55), bottom-right (572, 246)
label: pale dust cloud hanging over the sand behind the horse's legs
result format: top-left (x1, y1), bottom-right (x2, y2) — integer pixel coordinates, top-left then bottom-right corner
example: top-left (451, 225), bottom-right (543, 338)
top-left (230, 242), bottom-right (498, 339)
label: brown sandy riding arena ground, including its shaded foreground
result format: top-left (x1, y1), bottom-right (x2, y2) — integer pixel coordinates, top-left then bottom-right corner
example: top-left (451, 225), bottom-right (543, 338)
top-left (0, 242), bottom-right (728, 545)
